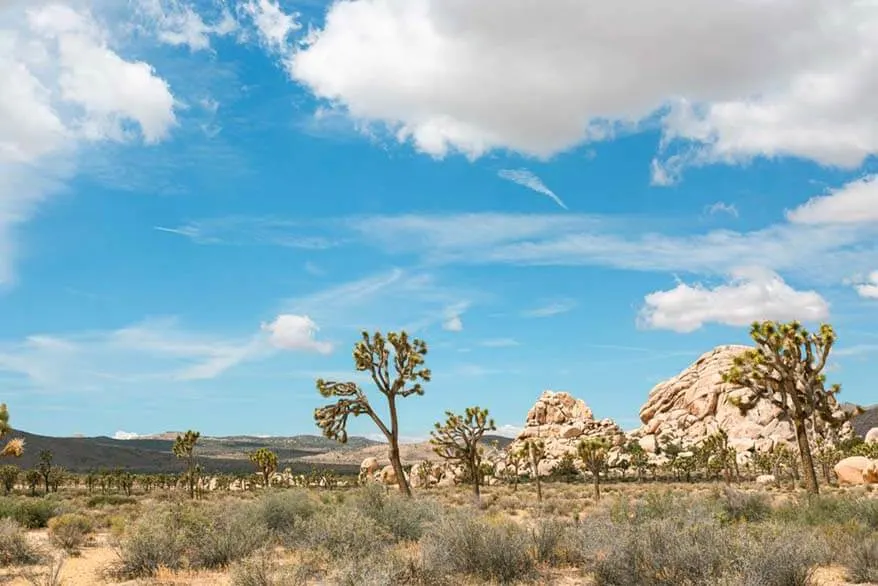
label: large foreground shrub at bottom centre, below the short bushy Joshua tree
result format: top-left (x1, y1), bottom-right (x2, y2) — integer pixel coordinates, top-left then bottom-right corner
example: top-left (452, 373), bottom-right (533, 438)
top-left (421, 513), bottom-right (534, 583)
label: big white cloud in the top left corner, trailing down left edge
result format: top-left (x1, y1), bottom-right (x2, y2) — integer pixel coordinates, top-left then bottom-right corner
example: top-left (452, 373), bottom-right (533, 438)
top-left (0, 0), bottom-right (176, 284)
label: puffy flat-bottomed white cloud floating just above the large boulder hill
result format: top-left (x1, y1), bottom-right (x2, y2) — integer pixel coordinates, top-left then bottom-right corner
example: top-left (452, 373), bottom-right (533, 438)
top-left (639, 268), bottom-right (829, 332)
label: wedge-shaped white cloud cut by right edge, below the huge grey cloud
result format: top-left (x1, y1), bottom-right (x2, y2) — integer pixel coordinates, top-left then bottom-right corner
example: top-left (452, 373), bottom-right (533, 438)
top-left (787, 175), bottom-right (878, 224)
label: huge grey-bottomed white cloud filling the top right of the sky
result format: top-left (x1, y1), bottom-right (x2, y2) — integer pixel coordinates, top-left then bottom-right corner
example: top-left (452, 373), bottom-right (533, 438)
top-left (285, 0), bottom-right (878, 176)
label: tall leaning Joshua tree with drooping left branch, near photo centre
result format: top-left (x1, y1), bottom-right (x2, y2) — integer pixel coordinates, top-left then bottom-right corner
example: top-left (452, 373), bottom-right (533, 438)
top-left (314, 332), bottom-right (430, 496)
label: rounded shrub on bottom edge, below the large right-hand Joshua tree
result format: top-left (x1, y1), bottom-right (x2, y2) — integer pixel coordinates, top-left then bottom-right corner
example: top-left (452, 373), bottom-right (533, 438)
top-left (737, 527), bottom-right (828, 586)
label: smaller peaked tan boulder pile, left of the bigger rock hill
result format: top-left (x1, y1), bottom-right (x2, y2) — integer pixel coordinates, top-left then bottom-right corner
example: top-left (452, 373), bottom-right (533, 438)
top-left (508, 391), bottom-right (625, 476)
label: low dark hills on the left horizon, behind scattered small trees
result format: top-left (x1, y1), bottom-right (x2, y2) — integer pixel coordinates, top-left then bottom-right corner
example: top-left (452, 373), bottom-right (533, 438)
top-left (10, 431), bottom-right (377, 473)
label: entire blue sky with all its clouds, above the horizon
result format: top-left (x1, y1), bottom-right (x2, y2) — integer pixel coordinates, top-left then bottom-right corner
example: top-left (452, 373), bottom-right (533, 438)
top-left (0, 0), bottom-right (878, 439)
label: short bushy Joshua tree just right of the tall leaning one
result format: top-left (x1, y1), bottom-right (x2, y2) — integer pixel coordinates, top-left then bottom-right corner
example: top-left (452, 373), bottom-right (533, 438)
top-left (430, 407), bottom-right (497, 501)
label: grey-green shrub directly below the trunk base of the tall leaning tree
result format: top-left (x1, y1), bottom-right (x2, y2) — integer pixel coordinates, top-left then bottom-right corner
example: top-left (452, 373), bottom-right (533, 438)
top-left (350, 484), bottom-right (437, 541)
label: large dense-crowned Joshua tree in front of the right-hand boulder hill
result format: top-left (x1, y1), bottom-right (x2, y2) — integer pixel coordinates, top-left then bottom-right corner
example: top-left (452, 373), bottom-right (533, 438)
top-left (723, 321), bottom-right (841, 494)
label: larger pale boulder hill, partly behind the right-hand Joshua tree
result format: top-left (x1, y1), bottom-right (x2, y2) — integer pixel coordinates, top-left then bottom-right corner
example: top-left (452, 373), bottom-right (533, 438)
top-left (631, 346), bottom-right (849, 454)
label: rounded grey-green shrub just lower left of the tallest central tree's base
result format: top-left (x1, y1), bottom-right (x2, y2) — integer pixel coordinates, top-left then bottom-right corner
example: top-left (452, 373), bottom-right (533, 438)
top-left (304, 507), bottom-right (389, 558)
